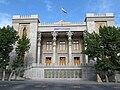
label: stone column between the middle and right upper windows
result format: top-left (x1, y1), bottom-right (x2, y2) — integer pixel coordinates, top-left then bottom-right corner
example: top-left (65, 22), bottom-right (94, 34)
top-left (67, 31), bottom-right (73, 65)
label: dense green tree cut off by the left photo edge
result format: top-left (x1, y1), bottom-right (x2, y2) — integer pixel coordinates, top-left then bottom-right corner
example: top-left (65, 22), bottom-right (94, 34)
top-left (0, 26), bottom-right (18, 80)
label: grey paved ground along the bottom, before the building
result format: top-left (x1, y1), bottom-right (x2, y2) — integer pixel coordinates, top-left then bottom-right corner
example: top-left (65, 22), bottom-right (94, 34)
top-left (0, 80), bottom-right (120, 90)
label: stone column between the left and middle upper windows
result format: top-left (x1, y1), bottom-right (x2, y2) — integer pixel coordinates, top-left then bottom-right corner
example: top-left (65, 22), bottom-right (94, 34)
top-left (52, 31), bottom-right (57, 65)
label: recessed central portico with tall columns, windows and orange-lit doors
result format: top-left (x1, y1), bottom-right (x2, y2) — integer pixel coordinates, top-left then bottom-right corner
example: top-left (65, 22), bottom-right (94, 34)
top-left (36, 28), bottom-right (87, 66)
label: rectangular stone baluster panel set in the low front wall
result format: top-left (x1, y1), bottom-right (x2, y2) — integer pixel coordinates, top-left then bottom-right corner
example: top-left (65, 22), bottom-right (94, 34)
top-left (44, 69), bottom-right (82, 78)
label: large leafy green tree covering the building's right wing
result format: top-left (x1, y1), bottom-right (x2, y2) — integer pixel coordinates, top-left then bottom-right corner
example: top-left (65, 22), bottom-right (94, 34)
top-left (83, 26), bottom-right (120, 81)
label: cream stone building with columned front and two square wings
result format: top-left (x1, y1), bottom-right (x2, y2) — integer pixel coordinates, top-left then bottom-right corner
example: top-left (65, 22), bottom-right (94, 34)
top-left (11, 13), bottom-right (114, 80)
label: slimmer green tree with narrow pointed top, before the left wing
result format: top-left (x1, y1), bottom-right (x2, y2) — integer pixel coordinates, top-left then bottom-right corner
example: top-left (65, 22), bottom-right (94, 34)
top-left (9, 28), bottom-right (30, 80)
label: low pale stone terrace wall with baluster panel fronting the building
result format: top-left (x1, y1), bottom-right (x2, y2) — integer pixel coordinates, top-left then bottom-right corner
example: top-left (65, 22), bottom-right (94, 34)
top-left (25, 65), bottom-right (96, 81)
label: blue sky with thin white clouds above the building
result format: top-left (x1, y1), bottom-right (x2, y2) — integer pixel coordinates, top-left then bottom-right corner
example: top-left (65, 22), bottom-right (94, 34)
top-left (0, 0), bottom-right (120, 26)
